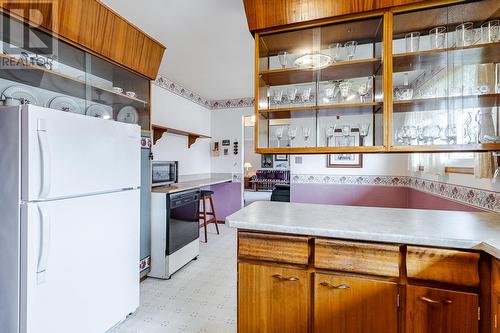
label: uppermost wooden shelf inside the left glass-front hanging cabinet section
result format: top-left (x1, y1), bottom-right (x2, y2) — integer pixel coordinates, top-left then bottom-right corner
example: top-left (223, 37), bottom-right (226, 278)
top-left (260, 58), bottom-right (381, 86)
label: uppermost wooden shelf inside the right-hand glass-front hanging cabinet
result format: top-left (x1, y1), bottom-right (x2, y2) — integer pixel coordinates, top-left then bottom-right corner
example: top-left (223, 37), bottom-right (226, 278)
top-left (392, 42), bottom-right (500, 73)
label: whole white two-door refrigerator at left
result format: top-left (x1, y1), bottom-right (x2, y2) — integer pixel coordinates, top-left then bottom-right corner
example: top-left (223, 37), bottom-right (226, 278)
top-left (0, 105), bottom-right (140, 333)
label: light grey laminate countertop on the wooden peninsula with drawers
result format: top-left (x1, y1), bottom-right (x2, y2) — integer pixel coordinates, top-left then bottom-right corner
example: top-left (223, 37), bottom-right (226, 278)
top-left (226, 201), bottom-right (500, 259)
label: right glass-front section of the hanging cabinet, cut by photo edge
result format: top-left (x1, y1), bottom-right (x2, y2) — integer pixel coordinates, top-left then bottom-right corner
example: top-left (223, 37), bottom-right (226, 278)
top-left (391, 0), bottom-right (500, 151)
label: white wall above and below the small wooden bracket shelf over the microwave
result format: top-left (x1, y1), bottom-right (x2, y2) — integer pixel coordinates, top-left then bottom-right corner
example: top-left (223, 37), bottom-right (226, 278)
top-left (151, 84), bottom-right (211, 175)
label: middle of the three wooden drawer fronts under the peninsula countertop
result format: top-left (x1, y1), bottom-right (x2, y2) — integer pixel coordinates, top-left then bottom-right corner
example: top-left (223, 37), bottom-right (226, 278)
top-left (314, 238), bottom-right (400, 277)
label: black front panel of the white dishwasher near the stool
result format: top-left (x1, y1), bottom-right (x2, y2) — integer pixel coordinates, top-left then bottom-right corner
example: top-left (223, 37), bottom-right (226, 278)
top-left (166, 190), bottom-right (200, 255)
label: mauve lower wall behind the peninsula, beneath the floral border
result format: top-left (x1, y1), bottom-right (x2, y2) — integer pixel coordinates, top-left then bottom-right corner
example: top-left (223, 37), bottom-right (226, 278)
top-left (290, 183), bottom-right (481, 212)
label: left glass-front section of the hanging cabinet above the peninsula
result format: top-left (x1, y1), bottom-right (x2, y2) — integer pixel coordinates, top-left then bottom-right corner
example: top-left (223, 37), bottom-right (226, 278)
top-left (256, 14), bottom-right (384, 152)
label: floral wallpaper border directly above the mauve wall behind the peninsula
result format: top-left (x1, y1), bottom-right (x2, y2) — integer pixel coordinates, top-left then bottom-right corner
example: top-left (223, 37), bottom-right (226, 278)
top-left (291, 174), bottom-right (500, 213)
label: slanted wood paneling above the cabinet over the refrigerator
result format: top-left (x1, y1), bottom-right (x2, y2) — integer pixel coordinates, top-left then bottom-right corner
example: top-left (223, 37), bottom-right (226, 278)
top-left (0, 0), bottom-right (165, 80)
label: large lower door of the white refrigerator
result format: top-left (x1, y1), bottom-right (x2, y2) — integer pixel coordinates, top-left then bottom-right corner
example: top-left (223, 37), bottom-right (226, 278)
top-left (21, 190), bottom-right (140, 333)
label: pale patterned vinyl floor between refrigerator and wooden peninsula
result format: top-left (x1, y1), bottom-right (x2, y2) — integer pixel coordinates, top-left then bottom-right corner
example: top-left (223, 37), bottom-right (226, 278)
top-left (109, 225), bottom-right (237, 333)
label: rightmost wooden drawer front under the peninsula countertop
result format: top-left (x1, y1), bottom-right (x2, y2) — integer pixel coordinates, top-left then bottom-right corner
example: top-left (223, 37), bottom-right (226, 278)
top-left (406, 246), bottom-right (479, 287)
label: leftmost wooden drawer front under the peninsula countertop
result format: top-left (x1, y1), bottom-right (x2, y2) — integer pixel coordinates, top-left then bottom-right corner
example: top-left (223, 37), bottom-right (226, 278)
top-left (238, 232), bottom-right (309, 265)
